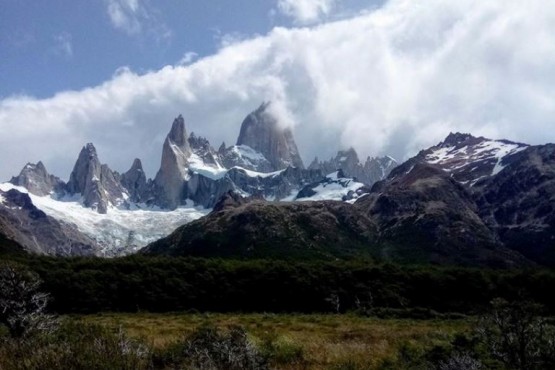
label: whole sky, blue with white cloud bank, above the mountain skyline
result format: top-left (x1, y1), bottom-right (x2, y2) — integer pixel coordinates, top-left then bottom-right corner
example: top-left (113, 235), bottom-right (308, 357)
top-left (0, 0), bottom-right (555, 181)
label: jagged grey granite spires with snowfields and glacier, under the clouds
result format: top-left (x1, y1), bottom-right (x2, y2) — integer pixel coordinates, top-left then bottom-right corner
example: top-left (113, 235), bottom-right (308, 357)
top-left (0, 102), bottom-right (397, 256)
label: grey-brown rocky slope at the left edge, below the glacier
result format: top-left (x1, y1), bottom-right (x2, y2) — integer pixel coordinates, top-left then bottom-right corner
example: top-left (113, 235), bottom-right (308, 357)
top-left (0, 189), bottom-right (100, 256)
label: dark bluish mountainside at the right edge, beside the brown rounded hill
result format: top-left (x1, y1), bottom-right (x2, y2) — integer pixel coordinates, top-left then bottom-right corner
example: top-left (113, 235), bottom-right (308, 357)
top-left (474, 144), bottom-right (555, 266)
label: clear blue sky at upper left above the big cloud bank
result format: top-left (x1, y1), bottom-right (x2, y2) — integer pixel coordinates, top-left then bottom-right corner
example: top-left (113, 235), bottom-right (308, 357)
top-left (0, 0), bottom-right (377, 98)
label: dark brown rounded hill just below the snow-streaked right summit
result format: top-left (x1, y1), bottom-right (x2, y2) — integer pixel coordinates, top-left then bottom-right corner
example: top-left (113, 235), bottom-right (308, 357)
top-left (355, 164), bottom-right (526, 266)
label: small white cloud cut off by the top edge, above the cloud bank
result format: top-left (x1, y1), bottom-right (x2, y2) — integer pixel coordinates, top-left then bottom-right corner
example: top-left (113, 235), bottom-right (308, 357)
top-left (277, 0), bottom-right (337, 24)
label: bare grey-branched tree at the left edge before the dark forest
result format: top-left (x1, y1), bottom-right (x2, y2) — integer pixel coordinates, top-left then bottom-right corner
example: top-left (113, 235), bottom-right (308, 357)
top-left (0, 263), bottom-right (57, 338)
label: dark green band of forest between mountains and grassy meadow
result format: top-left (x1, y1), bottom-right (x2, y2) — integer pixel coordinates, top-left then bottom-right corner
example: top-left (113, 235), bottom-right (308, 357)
top-left (3, 256), bottom-right (555, 316)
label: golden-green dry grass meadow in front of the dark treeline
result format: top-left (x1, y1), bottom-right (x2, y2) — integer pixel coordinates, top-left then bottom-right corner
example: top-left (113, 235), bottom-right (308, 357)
top-left (74, 313), bottom-right (471, 369)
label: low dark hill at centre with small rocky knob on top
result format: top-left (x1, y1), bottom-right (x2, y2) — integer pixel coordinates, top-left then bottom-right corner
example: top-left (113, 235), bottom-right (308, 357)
top-left (142, 193), bottom-right (376, 259)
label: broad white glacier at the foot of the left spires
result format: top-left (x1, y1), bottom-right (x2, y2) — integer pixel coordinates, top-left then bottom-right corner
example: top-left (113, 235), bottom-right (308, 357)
top-left (0, 183), bottom-right (210, 256)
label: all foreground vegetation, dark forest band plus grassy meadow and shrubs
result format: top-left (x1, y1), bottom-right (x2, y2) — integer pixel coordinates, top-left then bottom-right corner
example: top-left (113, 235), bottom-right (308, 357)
top-left (0, 256), bottom-right (555, 370)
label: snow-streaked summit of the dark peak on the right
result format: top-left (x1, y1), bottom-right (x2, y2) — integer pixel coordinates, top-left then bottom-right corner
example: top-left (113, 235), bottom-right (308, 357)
top-left (424, 133), bottom-right (528, 186)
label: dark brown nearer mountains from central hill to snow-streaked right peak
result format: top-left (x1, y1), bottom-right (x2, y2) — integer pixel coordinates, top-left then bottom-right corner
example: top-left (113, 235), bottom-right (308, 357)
top-left (142, 133), bottom-right (555, 267)
